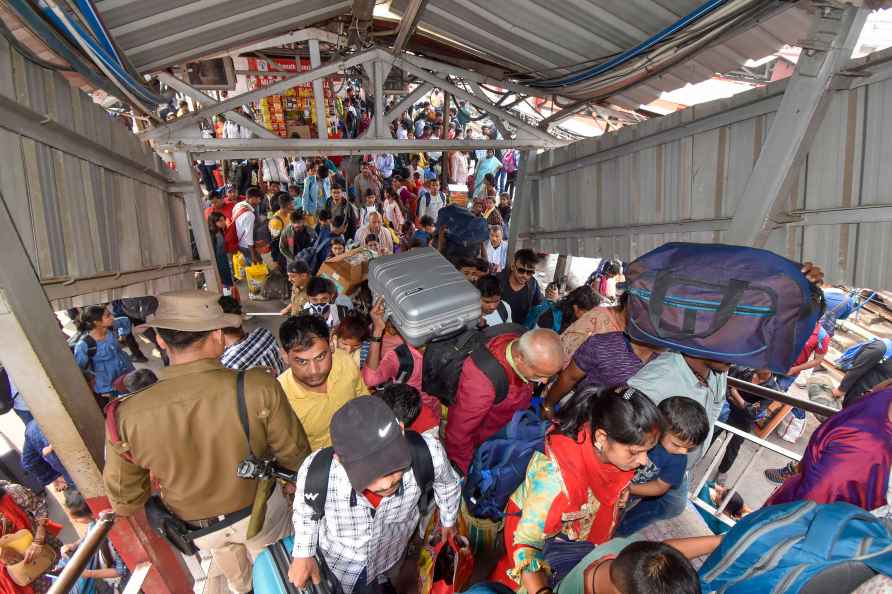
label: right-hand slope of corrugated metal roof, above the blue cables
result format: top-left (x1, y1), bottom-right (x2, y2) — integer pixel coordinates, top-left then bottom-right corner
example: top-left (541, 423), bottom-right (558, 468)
top-left (390, 0), bottom-right (808, 108)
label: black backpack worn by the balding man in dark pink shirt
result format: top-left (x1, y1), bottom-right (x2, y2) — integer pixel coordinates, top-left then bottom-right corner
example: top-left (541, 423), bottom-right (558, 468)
top-left (421, 324), bottom-right (527, 406)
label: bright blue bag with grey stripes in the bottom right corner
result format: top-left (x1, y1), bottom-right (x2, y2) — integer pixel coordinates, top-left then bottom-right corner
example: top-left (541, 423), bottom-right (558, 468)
top-left (700, 501), bottom-right (892, 594)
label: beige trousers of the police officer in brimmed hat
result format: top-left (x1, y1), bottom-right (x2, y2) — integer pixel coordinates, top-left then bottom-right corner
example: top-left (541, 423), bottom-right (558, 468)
top-left (195, 485), bottom-right (293, 594)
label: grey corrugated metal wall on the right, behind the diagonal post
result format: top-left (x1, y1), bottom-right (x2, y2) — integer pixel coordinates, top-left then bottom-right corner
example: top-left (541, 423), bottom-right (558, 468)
top-left (521, 48), bottom-right (892, 288)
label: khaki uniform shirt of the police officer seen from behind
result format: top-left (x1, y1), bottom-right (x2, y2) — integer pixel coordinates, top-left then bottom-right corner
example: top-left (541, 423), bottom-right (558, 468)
top-left (103, 359), bottom-right (310, 520)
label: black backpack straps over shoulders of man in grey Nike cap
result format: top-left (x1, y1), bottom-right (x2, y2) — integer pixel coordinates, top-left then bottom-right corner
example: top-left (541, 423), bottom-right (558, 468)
top-left (304, 429), bottom-right (434, 522)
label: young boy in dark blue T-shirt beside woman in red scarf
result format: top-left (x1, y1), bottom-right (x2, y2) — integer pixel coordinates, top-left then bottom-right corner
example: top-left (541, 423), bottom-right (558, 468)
top-left (617, 396), bottom-right (709, 536)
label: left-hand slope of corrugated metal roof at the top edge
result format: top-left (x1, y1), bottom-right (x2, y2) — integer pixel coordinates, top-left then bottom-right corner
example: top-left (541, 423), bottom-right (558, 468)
top-left (95, 0), bottom-right (353, 72)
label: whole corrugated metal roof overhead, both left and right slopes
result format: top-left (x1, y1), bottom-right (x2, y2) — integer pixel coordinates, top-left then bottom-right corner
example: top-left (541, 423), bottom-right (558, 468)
top-left (95, 0), bottom-right (808, 108)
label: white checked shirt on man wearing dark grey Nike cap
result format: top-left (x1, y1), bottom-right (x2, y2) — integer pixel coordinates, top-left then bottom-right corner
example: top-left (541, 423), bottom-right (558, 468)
top-left (292, 435), bottom-right (461, 592)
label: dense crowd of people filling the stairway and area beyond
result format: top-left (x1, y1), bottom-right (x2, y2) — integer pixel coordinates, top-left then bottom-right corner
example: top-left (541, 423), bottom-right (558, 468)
top-left (0, 91), bottom-right (892, 594)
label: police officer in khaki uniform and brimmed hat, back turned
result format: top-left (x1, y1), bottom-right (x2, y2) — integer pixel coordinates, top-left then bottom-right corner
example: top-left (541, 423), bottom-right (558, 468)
top-left (103, 291), bottom-right (310, 593)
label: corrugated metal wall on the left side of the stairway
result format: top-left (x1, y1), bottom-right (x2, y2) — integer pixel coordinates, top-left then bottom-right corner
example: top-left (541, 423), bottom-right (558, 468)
top-left (0, 39), bottom-right (194, 309)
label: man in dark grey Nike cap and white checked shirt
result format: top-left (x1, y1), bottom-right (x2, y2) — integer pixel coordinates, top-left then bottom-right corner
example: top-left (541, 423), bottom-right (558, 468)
top-left (288, 396), bottom-right (461, 594)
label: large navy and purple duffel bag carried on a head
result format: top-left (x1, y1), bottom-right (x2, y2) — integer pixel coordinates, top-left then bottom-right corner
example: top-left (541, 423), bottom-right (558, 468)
top-left (626, 243), bottom-right (824, 373)
